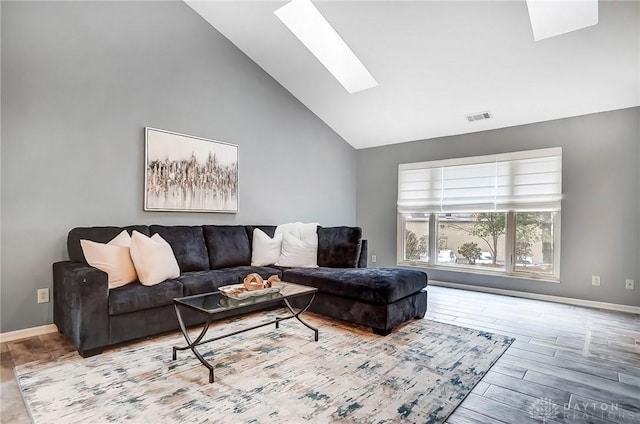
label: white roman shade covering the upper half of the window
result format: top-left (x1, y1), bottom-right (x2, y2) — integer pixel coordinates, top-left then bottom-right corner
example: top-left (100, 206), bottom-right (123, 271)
top-left (398, 147), bottom-right (562, 213)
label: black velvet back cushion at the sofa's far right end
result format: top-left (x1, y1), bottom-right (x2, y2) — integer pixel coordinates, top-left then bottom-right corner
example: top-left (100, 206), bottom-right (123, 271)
top-left (318, 227), bottom-right (362, 268)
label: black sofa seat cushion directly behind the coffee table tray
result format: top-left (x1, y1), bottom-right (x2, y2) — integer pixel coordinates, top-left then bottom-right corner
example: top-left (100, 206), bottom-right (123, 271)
top-left (179, 266), bottom-right (282, 296)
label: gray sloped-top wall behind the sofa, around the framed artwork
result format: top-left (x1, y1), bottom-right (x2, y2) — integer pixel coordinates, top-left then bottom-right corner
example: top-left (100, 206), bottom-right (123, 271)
top-left (0, 1), bottom-right (356, 332)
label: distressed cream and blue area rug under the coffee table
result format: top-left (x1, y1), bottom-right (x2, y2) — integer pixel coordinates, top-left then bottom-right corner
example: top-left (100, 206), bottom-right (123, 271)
top-left (16, 311), bottom-right (513, 424)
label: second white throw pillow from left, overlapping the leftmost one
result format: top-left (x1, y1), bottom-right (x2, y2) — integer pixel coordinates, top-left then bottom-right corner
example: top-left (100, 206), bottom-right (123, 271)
top-left (131, 231), bottom-right (180, 286)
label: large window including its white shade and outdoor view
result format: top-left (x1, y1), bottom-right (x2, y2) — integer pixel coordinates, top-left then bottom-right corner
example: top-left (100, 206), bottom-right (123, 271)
top-left (398, 148), bottom-right (562, 280)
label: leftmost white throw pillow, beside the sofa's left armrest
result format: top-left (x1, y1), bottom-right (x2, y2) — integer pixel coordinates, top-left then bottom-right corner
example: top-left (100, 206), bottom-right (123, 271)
top-left (80, 230), bottom-right (138, 289)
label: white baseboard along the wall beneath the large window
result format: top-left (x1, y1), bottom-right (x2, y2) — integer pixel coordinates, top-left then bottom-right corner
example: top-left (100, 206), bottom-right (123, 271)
top-left (429, 280), bottom-right (640, 314)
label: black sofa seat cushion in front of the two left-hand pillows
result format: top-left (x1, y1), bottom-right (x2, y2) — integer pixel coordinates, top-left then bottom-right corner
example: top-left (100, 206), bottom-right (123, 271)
top-left (109, 280), bottom-right (183, 315)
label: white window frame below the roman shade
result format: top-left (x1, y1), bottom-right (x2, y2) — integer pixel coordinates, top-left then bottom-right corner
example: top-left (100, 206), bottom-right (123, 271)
top-left (396, 211), bottom-right (561, 283)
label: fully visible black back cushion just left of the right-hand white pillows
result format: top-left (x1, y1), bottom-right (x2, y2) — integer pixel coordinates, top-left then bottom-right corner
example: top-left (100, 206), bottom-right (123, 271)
top-left (203, 225), bottom-right (251, 269)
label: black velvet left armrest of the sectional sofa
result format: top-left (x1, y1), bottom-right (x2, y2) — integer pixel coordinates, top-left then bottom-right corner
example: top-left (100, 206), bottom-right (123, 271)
top-left (53, 261), bottom-right (109, 356)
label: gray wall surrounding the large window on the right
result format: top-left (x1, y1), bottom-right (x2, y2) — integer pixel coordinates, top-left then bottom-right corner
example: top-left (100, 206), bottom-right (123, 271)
top-left (356, 108), bottom-right (640, 306)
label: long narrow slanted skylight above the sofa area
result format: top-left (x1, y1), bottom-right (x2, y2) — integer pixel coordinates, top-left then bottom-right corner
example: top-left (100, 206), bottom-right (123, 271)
top-left (274, 0), bottom-right (378, 94)
